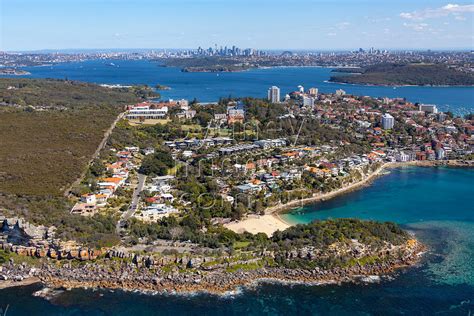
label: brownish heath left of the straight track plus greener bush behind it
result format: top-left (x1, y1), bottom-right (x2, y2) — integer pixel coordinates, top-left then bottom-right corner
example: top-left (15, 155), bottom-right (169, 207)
top-left (0, 79), bottom-right (139, 196)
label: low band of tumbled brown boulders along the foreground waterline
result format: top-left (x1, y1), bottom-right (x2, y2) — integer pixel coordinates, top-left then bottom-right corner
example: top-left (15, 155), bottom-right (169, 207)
top-left (0, 243), bottom-right (425, 294)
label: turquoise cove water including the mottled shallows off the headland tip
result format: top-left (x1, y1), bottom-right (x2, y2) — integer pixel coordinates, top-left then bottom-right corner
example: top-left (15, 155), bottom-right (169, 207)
top-left (282, 167), bottom-right (474, 286)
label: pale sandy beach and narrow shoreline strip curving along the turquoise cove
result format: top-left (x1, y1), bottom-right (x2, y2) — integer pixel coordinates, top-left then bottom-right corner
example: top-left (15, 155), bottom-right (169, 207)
top-left (225, 160), bottom-right (474, 236)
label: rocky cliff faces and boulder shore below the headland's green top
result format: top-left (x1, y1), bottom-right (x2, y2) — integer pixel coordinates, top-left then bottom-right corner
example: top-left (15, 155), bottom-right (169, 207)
top-left (0, 223), bottom-right (425, 294)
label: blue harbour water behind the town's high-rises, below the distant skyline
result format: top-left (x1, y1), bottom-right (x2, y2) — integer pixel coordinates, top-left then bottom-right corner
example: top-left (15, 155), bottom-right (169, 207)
top-left (3, 60), bottom-right (474, 114)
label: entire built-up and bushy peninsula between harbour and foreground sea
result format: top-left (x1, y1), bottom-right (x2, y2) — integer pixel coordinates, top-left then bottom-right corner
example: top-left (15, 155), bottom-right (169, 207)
top-left (0, 79), bottom-right (474, 293)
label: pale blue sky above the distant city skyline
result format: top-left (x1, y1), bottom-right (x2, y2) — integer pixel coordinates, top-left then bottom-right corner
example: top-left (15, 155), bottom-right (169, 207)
top-left (0, 0), bottom-right (474, 51)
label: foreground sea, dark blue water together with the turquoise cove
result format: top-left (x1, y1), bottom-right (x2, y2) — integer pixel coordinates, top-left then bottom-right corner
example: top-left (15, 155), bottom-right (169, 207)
top-left (0, 167), bottom-right (474, 315)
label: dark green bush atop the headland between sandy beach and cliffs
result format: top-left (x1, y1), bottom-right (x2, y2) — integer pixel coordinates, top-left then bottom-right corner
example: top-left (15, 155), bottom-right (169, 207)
top-left (127, 215), bottom-right (410, 267)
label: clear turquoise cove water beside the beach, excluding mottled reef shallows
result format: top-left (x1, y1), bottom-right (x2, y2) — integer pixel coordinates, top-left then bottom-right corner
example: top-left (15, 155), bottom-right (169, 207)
top-left (282, 167), bottom-right (474, 224)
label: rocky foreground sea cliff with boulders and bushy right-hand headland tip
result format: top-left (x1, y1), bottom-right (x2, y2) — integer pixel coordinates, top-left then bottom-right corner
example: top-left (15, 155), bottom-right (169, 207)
top-left (0, 215), bottom-right (425, 293)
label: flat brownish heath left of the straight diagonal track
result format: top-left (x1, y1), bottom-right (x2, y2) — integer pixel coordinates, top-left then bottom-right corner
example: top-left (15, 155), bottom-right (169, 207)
top-left (0, 106), bottom-right (119, 196)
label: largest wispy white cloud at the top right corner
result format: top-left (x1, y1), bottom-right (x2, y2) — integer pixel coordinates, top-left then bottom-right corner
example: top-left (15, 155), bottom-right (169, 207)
top-left (400, 3), bottom-right (474, 21)
